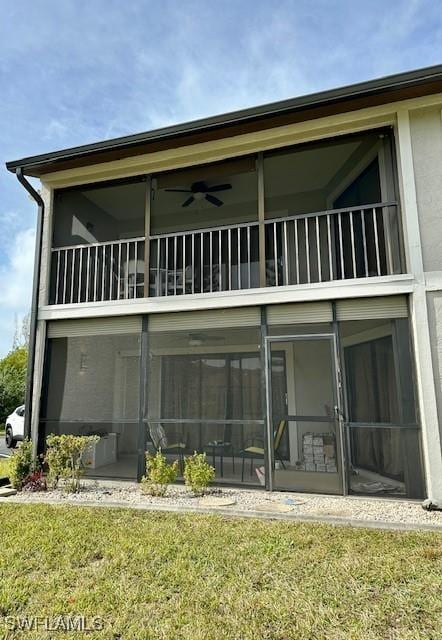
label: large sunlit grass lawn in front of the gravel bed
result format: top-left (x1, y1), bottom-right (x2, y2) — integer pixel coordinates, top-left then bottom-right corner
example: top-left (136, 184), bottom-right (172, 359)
top-left (0, 503), bottom-right (442, 640)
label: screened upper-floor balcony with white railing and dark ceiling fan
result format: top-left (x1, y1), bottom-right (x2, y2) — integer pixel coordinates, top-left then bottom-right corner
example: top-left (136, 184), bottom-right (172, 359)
top-left (50, 133), bottom-right (403, 304)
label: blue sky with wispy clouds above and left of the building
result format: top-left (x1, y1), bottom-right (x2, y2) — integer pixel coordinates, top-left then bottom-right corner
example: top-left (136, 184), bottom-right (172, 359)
top-left (0, 0), bottom-right (442, 356)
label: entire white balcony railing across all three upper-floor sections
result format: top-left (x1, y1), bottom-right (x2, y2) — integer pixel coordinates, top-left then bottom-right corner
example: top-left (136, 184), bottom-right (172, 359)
top-left (50, 203), bottom-right (401, 304)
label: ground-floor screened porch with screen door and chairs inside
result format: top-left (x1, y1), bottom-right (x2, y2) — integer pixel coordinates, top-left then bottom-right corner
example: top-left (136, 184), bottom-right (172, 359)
top-left (39, 296), bottom-right (425, 498)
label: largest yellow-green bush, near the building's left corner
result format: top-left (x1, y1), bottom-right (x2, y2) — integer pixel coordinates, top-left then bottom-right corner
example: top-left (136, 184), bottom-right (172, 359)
top-left (45, 434), bottom-right (100, 493)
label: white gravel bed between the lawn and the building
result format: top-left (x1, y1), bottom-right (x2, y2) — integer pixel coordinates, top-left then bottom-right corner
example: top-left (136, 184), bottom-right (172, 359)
top-left (4, 481), bottom-right (442, 527)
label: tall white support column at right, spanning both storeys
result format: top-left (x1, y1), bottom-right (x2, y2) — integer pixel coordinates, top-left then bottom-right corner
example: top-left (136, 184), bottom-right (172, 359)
top-left (397, 110), bottom-right (442, 505)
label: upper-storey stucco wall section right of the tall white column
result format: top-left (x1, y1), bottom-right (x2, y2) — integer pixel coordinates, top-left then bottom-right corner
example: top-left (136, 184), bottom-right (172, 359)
top-left (410, 104), bottom-right (442, 271)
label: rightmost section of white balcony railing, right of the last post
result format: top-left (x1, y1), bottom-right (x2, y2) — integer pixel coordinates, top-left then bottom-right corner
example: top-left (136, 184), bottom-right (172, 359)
top-left (265, 203), bottom-right (400, 286)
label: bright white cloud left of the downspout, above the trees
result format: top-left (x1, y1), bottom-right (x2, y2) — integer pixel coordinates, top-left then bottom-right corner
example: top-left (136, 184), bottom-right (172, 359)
top-left (0, 229), bottom-right (35, 356)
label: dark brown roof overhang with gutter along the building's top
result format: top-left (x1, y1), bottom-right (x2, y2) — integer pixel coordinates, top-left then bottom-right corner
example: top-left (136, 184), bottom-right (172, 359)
top-left (6, 65), bottom-right (442, 177)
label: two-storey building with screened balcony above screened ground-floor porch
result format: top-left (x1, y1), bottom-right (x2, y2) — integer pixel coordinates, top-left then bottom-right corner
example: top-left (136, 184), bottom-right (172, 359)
top-left (7, 66), bottom-right (442, 502)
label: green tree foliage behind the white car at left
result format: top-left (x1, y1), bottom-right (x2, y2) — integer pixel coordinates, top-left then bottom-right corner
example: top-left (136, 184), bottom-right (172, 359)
top-left (0, 346), bottom-right (28, 424)
